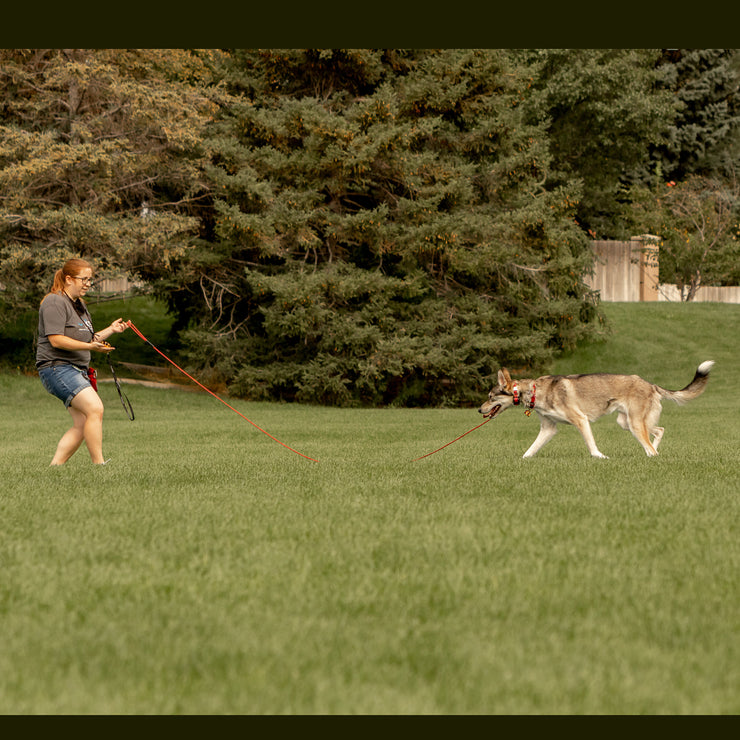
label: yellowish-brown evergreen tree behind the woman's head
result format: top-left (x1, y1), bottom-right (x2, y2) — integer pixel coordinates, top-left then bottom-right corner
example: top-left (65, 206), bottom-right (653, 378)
top-left (0, 49), bottom-right (220, 317)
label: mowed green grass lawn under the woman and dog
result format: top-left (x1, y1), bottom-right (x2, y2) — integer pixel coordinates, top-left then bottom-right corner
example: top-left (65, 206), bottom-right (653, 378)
top-left (0, 304), bottom-right (740, 714)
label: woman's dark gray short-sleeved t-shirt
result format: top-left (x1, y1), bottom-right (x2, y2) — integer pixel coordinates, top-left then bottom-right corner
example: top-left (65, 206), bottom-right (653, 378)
top-left (36, 293), bottom-right (94, 369)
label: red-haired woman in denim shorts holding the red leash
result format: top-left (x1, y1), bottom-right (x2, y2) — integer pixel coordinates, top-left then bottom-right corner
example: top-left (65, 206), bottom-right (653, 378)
top-left (36, 259), bottom-right (128, 465)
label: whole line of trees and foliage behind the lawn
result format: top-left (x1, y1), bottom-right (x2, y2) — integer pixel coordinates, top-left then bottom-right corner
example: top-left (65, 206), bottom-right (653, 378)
top-left (0, 49), bottom-right (740, 405)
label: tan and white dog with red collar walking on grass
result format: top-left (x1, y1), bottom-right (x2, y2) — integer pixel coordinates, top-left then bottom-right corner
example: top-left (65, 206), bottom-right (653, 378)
top-left (478, 360), bottom-right (714, 459)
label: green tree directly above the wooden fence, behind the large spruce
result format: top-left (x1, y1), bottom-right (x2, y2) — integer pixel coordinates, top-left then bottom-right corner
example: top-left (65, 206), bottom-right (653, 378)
top-left (517, 49), bottom-right (675, 239)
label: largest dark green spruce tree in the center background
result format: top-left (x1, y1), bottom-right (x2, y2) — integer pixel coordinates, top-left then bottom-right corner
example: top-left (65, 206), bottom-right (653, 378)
top-left (176, 49), bottom-right (595, 404)
